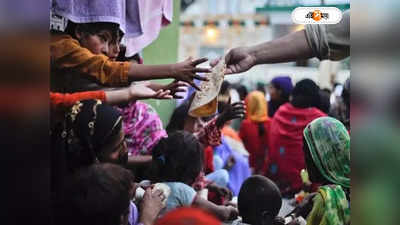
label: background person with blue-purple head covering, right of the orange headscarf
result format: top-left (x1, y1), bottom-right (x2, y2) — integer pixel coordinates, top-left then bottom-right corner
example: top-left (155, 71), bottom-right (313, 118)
top-left (268, 76), bottom-right (293, 117)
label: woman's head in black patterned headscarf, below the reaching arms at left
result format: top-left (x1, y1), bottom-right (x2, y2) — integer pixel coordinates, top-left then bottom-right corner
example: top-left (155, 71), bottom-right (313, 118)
top-left (51, 100), bottom-right (128, 181)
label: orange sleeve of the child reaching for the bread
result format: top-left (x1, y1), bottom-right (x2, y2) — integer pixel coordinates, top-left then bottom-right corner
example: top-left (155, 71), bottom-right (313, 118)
top-left (50, 34), bottom-right (131, 86)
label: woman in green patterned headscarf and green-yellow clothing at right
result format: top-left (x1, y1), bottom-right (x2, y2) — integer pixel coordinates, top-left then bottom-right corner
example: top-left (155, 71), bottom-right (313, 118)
top-left (303, 117), bottom-right (350, 225)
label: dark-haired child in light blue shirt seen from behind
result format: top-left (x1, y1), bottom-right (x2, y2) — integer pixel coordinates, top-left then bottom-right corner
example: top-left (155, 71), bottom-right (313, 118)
top-left (152, 131), bottom-right (237, 221)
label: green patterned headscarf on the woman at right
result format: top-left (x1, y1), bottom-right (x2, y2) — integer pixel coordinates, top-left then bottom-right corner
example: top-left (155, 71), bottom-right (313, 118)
top-left (304, 117), bottom-right (350, 188)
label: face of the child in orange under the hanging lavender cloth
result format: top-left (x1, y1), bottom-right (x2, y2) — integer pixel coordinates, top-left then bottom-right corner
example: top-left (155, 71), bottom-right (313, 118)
top-left (77, 31), bottom-right (112, 56)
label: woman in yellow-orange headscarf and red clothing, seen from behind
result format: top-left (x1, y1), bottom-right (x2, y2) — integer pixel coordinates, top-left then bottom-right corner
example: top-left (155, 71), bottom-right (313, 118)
top-left (239, 91), bottom-right (270, 174)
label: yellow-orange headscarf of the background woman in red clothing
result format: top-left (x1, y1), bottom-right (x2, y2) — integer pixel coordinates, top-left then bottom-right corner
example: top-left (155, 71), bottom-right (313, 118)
top-left (245, 91), bottom-right (269, 122)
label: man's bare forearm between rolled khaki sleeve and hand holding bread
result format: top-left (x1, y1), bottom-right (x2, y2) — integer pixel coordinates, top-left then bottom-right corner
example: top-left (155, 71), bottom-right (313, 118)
top-left (250, 30), bottom-right (314, 64)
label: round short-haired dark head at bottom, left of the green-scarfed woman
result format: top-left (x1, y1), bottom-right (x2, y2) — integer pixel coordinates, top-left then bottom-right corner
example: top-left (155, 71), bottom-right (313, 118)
top-left (238, 175), bottom-right (282, 225)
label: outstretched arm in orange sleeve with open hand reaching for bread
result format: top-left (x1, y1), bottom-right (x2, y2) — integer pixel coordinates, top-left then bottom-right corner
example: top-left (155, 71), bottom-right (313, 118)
top-left (50, 37), bottom-right (211, 90)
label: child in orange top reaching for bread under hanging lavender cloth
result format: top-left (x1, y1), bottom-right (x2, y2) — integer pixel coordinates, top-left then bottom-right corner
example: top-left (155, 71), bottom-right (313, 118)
top-left (50, 21), bottom-right (210, 92)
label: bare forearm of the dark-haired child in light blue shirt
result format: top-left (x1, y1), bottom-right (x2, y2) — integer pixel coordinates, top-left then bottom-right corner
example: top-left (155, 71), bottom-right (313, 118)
top-left (192, 197), bottom-right (239, 221)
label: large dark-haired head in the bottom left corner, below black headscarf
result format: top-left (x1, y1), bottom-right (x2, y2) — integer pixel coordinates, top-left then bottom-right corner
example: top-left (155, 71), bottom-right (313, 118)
top-left (54, 163), bottom-right (134, 225)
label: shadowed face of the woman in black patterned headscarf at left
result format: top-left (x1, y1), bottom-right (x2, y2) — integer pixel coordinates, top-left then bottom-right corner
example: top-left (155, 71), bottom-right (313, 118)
top-left (102, 126), bottom-right (128, 166)
